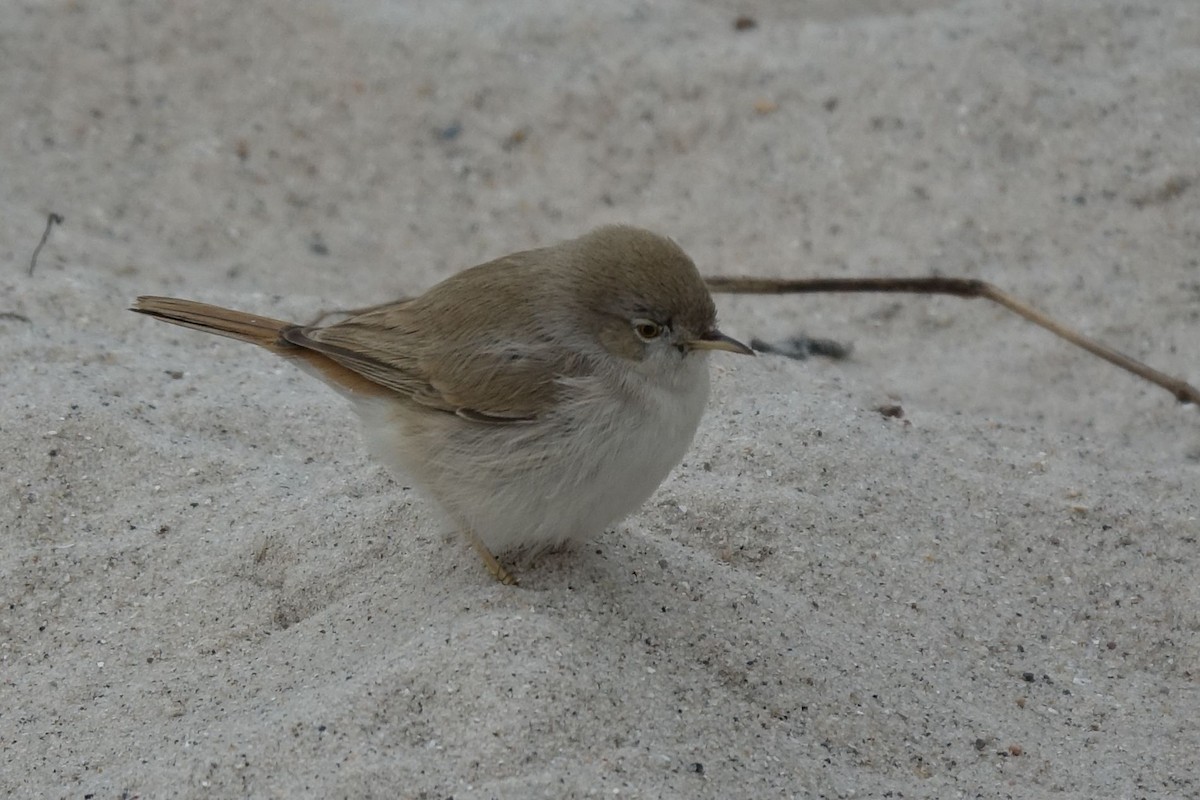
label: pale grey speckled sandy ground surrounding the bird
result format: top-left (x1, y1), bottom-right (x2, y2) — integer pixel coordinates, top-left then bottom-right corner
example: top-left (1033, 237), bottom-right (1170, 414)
top-left (0, 0), bottom-right (1200, 800)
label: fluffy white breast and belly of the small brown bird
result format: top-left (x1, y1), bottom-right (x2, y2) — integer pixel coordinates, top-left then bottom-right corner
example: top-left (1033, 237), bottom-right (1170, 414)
top-left (359, 354), bottom-right (708, 553)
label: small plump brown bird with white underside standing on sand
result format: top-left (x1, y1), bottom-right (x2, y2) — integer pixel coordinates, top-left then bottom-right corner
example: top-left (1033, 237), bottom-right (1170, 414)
top-left (133, 225), bottom-right (754, 583)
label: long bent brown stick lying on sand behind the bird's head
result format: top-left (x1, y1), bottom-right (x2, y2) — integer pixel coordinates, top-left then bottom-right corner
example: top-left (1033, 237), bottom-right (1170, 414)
top-left (706, 277), bottom-right (1200, 405)
